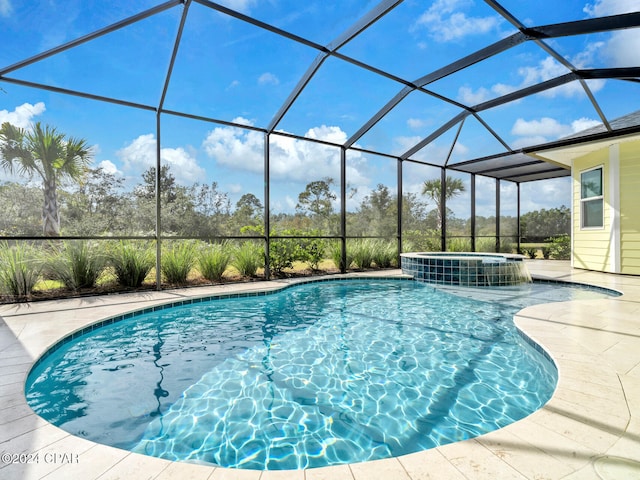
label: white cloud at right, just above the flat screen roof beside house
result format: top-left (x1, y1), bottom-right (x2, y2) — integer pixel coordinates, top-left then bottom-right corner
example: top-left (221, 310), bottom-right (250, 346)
top-left (511, 117), bottom-right (601, 148)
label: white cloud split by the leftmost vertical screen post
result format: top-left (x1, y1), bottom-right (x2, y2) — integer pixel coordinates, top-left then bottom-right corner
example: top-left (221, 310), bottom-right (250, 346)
top-left (116, 133), bottom-right (206, 184)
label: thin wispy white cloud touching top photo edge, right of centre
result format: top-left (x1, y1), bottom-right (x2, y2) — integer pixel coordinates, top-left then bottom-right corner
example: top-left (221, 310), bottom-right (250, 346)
top-left (415, 0), bottom-right (501, 42)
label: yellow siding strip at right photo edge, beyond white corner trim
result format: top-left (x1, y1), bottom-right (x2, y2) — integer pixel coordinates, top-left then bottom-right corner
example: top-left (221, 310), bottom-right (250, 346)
top-left (620, 141), bottom-right (640, 275)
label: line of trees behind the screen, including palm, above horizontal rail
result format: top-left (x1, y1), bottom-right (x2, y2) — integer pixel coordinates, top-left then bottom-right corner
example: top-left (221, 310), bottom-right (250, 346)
top-left (0, 123), bottom-right (570, 238)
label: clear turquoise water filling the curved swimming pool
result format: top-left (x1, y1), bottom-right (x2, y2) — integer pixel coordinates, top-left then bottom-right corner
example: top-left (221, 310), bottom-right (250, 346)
top-left (26, 280), bottom-right (616, 470)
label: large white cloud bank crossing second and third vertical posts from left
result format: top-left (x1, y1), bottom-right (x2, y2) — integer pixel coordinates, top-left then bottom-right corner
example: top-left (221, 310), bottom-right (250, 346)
top-left (203, 119), bottom-right (369, 184)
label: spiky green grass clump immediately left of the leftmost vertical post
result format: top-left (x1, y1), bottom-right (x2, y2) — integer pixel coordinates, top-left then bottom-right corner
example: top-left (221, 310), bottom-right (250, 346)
top-left (108, 241), bottom-right (156, 288)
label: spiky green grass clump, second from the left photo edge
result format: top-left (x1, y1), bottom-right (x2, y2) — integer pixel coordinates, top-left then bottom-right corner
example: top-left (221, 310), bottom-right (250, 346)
top-left (45, 240), bottom-right (106, 290)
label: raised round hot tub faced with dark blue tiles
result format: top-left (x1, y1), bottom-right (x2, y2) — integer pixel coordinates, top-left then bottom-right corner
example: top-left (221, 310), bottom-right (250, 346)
top-left (400, 252), bottom-right (531, 287)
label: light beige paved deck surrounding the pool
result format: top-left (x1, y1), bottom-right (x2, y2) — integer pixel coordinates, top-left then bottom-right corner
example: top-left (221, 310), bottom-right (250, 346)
top-left (0, 260), bottom-right (640, 480)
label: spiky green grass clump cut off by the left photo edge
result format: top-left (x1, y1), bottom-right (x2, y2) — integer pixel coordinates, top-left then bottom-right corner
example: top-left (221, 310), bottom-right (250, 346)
top-left (0, 242), bottom-right (42, 300)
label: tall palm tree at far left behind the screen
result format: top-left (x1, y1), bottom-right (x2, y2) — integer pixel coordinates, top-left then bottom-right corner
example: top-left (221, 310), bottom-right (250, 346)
top-left (0, 122), bottom-right (92, 237)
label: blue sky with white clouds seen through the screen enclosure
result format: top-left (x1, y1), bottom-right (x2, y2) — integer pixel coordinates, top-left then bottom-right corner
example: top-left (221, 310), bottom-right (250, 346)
top-left (0, 0), bottom-right (640, 216)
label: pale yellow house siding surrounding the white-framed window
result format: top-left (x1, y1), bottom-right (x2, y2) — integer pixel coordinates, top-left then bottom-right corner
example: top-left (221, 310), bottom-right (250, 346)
top-left (572, 148), bottom-right (611, 272)
